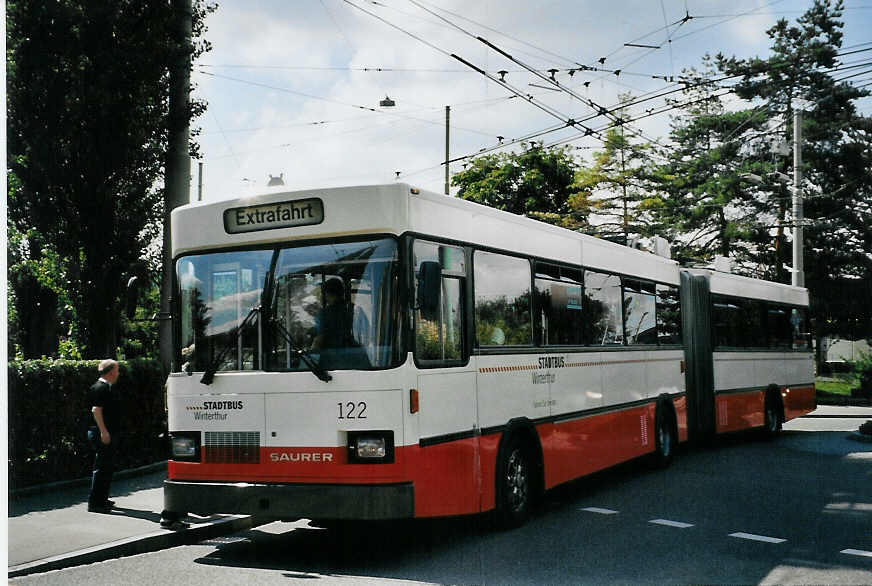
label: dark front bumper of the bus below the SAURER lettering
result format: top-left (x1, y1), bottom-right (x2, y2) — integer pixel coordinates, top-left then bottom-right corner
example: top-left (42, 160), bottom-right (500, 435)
top-left (164, 480), bottom-right (415, 521)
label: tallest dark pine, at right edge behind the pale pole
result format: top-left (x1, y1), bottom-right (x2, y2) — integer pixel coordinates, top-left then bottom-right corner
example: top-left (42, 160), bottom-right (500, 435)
top-left (717, 0), bottom-right (872, 346)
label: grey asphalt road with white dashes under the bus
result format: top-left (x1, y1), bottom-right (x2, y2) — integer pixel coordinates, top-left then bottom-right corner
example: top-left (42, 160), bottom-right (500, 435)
top-left (11, 420), bottom-right (872, 586)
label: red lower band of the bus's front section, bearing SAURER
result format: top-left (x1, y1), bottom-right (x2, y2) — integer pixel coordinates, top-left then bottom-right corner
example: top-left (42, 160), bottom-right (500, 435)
top-left (169, 397), bottom-right (687, 517)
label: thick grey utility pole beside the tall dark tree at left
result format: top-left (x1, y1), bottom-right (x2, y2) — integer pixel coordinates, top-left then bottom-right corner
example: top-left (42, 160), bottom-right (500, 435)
top-left (159, 0), bottom-right (193, 373)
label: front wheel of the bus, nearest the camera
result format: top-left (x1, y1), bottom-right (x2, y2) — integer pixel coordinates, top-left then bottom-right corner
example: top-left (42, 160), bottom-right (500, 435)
top-left (495, 434), bottom-right (536, 529)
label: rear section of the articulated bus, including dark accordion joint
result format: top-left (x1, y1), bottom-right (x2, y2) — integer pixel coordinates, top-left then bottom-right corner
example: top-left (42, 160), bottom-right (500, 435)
top-left (681, 269), bottom-right (816, 437)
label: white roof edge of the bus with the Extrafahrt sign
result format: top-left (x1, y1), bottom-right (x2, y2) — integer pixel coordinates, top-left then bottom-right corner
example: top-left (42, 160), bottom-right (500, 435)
top-left (172, 183), bottom-right (808, 294)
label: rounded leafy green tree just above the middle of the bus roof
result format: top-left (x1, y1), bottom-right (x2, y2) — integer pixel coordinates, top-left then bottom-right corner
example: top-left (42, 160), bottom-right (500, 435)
top-left (451, 143), bottom-right (590, 229)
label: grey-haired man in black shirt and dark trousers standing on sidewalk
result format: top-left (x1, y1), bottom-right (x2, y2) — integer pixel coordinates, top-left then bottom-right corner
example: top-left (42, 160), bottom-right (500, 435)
top-left (88, 359), bottom-right (121, 513)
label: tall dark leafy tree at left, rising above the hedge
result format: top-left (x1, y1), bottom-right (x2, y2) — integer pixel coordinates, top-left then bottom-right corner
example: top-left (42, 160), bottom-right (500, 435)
top-left (7, 0), bottom-right (215, 356)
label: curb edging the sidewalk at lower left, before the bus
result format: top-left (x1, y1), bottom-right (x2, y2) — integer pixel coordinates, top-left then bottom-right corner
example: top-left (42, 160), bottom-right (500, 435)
top-left (7, 515), bottom-right (259, 578)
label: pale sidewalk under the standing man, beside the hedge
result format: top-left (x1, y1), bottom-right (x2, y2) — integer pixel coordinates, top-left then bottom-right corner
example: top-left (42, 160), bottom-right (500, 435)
top-left (8, 467), bottom-right (252, 578)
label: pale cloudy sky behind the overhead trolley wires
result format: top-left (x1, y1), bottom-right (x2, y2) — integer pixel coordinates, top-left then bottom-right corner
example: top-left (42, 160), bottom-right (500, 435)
top-left (191, 0), bottom-right (872, 201)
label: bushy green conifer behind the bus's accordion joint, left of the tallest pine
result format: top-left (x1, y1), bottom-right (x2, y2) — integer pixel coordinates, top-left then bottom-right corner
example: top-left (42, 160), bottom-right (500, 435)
top-left (649, 57), bottom-right (783, 263)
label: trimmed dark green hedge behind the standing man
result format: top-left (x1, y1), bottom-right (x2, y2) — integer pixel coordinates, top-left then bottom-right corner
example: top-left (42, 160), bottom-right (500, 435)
top-left (8, 359), bottom-right (167, 489)
